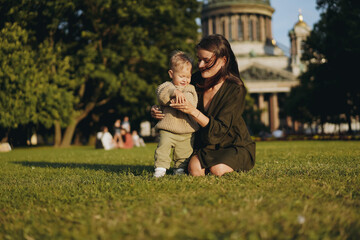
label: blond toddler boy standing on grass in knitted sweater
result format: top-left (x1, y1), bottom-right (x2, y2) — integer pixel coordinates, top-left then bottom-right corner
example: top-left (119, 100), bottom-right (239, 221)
top-left (154, 51), bottom-right (199, 177)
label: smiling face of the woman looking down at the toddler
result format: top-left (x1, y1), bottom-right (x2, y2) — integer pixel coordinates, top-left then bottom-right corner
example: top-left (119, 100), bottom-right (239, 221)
top-left (197, 49), bottom-right (226, 79)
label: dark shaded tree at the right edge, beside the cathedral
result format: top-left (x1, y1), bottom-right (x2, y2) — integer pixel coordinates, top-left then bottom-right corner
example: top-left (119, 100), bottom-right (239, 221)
top-left (290, 0), bottom-right (360, 132)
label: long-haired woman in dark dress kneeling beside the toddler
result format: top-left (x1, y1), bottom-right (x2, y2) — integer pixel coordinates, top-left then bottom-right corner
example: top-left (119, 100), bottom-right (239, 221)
top-left (152, 34), bottom-right (255, 176)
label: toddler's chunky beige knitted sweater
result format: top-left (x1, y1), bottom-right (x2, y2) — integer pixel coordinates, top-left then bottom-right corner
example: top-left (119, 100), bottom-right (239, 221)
top-left (156, 82), bottom-right (199, 134)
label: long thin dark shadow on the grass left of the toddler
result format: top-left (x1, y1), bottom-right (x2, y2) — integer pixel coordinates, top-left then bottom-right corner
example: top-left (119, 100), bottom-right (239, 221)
top-left (12, 161), bottom-right (154, 176)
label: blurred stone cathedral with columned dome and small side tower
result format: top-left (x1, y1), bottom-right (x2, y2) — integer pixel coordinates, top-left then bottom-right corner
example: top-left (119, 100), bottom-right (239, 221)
top-left (201, 0), bottom-right (310, 131)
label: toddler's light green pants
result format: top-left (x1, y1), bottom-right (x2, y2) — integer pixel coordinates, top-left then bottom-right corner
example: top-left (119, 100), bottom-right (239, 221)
top-left (155, 130), bottom-right (194, 169)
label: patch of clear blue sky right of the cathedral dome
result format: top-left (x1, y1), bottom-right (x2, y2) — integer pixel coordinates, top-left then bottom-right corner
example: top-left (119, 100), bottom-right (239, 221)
top-left (270, 0), bottom-right (320, 48)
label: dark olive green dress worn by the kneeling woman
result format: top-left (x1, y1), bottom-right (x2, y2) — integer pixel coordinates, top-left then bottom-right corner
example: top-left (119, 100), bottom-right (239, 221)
top-left (194, 76), bottom-right (255, 171)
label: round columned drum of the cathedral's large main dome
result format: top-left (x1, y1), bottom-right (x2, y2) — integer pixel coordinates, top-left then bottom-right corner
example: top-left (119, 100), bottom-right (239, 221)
top-left (201, 0), bottom-right (275, 45)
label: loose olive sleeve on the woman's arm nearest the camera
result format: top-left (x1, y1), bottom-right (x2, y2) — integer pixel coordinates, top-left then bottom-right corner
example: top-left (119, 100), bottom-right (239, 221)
top-left (201, 86), bottom-right (246, 145)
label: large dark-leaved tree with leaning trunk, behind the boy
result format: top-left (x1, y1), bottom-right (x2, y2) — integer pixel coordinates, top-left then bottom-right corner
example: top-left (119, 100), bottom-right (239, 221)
top-left (0, 0), bottom-right (199, 146)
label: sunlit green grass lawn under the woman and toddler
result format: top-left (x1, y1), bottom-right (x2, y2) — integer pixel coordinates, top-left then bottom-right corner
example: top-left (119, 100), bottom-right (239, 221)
top-left (0, 141), bottom-right (360, 240)
